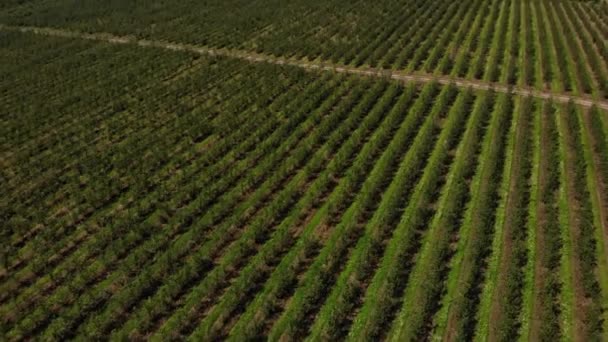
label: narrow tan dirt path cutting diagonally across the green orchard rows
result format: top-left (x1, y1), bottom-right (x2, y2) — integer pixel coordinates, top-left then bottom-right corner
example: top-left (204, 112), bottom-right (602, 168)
top-left (0, 25), bottom-right (608, 110)
